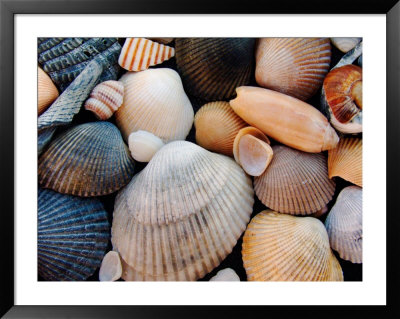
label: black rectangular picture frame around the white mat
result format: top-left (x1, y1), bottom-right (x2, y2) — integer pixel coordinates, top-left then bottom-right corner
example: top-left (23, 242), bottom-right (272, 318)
top-left (0, 0), bottom-right (400, 318)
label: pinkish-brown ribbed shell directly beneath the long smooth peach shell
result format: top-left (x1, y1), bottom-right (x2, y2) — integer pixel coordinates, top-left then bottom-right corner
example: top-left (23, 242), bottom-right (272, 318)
top-left (254, 145), bottom-right (335, 215)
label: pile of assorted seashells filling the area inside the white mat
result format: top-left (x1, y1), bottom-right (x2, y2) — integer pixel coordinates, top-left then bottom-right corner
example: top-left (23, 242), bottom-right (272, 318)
top-left (38, 35), bottom-right (363, 281)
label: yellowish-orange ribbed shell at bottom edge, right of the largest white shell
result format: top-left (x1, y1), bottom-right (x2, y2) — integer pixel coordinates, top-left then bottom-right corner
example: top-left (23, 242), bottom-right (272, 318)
top-left (242, 210), bottom-right (343, 281)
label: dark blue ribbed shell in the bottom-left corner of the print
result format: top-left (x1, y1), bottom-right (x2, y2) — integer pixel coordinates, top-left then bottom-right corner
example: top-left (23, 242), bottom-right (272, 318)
top-left (38, 189), bottom-right (110, 280)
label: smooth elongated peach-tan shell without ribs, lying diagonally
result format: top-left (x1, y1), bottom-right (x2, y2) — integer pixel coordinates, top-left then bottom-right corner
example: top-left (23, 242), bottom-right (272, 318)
top-left (229, 86), bottom-right (339, 153)
